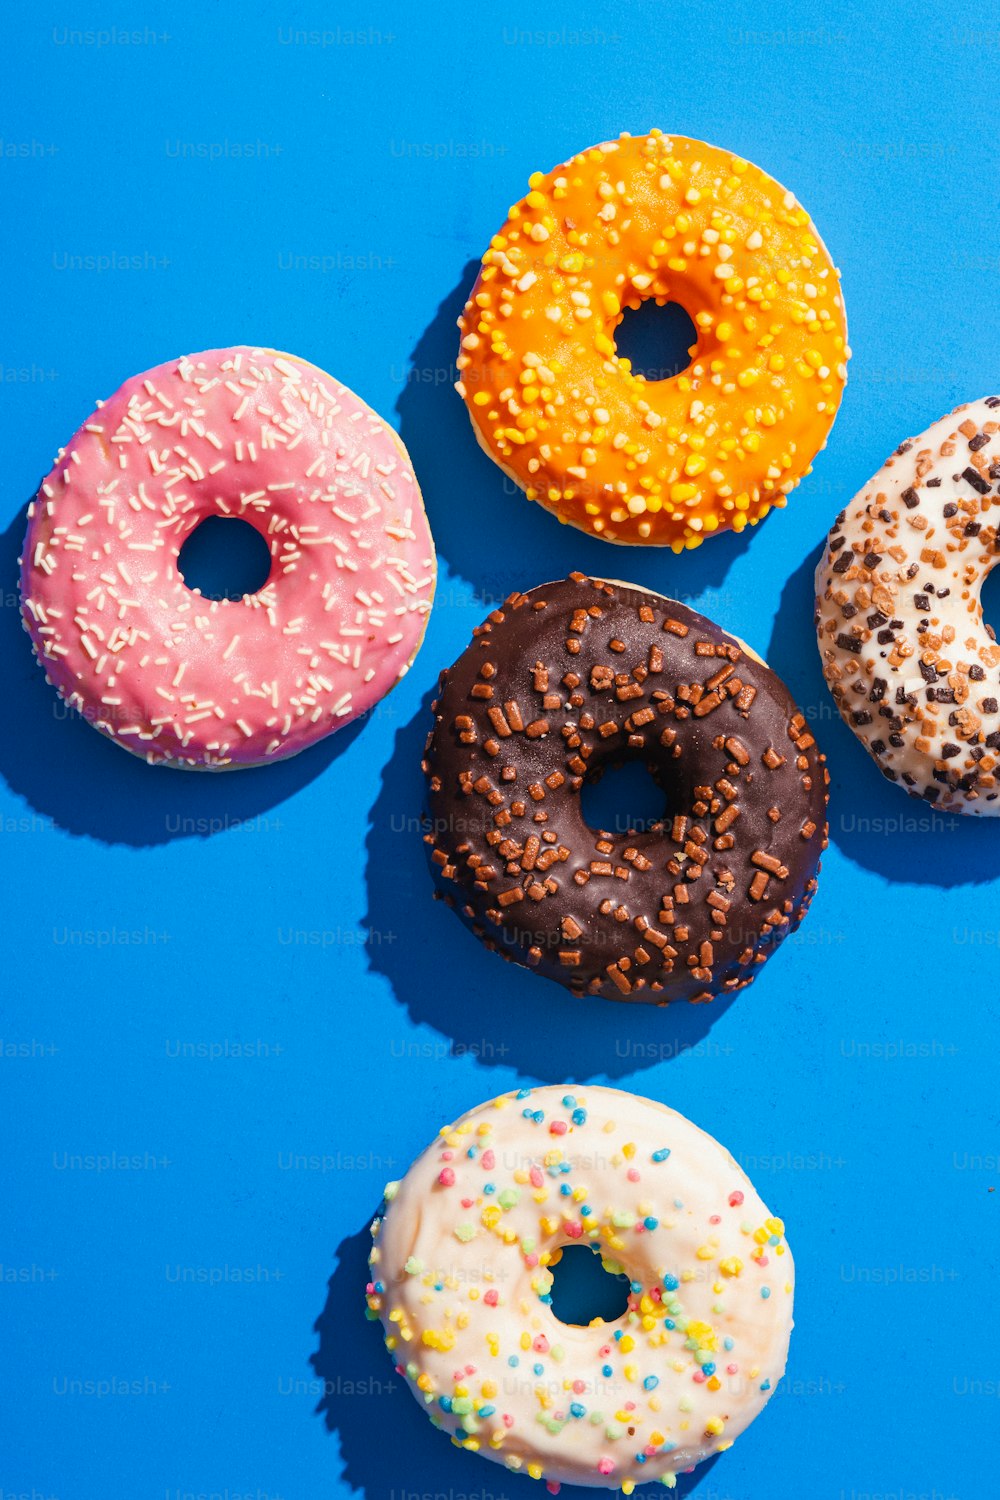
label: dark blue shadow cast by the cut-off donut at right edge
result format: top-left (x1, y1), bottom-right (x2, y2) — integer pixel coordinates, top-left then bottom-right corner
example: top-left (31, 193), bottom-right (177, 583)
top-left (768, 540), bottom-right (1000, 882)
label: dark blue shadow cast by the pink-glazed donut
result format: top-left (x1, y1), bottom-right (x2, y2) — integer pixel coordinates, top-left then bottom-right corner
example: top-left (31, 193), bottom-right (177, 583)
top-left (0, 509), bottom-right (363, 848)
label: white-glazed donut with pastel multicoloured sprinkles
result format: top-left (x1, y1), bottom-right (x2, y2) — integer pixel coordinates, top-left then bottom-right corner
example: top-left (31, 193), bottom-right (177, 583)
top-left (367, 1086), bottom-right (795, 1494)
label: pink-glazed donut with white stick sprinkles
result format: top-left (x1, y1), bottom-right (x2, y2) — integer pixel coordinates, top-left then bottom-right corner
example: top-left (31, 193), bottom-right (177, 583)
top-left (21, 348), bottom-right (435, 771)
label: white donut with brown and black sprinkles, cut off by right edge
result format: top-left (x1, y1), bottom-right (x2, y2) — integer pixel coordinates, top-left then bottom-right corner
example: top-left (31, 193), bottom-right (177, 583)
top-left (816, 396), bottom-right (1000, 818)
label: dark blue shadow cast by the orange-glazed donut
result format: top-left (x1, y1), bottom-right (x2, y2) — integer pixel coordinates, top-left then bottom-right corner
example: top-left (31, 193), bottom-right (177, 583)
top-left (396, 261), bottom-right (753, 611)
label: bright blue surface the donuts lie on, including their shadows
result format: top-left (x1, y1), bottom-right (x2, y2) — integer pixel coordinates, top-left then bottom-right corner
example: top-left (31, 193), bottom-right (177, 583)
top-left (0, 0), bottom-right (1000, 1500)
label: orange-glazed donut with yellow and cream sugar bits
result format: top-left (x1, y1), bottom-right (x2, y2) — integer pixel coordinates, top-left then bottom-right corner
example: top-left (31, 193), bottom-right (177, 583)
top-left (457, 131), bottom-right (850, 552)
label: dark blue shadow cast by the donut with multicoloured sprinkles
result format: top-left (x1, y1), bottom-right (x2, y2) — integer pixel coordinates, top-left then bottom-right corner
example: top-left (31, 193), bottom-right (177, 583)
top-left (309, 1226), bottom-right (718, 1500)
